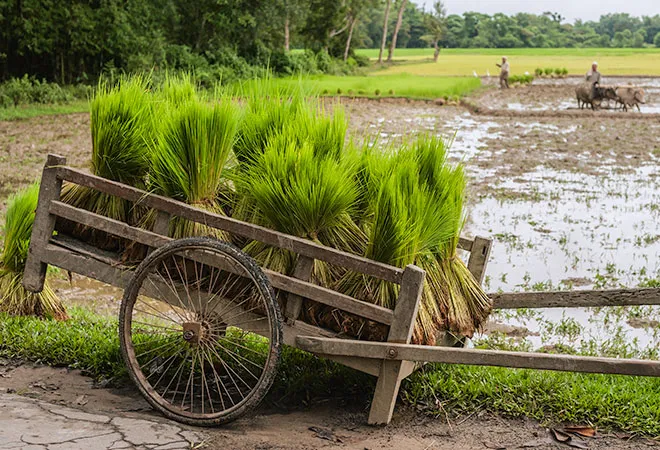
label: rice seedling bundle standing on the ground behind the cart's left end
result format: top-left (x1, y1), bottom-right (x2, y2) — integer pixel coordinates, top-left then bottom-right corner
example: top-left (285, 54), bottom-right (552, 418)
top-left (0, 184), bottom-right (68, 320)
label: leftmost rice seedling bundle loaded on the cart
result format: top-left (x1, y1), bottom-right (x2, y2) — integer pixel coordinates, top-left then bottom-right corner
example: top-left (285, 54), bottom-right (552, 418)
top-left (58, 77), bottom-right (155, 249)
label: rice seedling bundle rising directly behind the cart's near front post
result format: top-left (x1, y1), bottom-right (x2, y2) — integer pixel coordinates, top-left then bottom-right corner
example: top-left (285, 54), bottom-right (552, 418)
top-left (336, 153), bottom-right (453, 343)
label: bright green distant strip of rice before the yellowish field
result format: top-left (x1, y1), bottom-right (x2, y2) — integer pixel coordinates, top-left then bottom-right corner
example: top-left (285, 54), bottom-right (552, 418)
top-left (273, 72), bottom-right (481, 99)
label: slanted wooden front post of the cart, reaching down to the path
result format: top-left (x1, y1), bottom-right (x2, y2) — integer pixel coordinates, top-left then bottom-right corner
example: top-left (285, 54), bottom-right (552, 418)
top-left (369, 265), bottom-right (426, 425)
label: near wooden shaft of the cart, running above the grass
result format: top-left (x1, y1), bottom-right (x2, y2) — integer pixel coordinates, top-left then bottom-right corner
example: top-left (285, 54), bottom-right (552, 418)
top-left (296, 336), bottom-right (660, 377)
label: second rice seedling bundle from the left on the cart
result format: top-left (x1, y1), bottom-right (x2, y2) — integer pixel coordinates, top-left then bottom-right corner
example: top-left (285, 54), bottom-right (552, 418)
top-left (148, 100), bottom-right (240, 240)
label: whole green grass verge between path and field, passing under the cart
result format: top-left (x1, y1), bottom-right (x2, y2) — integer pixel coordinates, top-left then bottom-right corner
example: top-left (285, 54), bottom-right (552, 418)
top-left (0, 308), bottom-right (660, 436)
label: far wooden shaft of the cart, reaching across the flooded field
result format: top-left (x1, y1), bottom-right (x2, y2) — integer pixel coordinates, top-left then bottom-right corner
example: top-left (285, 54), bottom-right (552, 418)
top-left (488, 288), bottom-right (660, 309)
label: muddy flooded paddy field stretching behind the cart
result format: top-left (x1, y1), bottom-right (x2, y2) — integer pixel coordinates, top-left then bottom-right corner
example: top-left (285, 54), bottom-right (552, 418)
top-left (0, 91), bottom-right (660, 357)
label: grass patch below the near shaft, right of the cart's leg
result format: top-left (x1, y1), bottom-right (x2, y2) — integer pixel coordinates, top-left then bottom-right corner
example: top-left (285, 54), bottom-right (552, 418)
top-left (404, 364), bottom-right (660, 436)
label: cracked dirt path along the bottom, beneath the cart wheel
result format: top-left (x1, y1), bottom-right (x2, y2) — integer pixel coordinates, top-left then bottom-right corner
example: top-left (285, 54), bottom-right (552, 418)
top-left (0, 360), bottom-right (660, 450)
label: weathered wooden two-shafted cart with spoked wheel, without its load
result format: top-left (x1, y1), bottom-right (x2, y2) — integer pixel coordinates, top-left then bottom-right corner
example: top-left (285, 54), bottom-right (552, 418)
top-left (24, 155), bottom-right (660, 425)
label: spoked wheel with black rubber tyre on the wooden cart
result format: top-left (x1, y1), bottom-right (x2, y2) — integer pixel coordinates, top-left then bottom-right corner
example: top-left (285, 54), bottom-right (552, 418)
top-left (119, 238), bottom-right (282, 426)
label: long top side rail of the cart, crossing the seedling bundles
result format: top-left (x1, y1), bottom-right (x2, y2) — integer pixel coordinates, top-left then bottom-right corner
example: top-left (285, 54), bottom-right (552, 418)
top-left (58, 167), bottom-right (403, 283)
